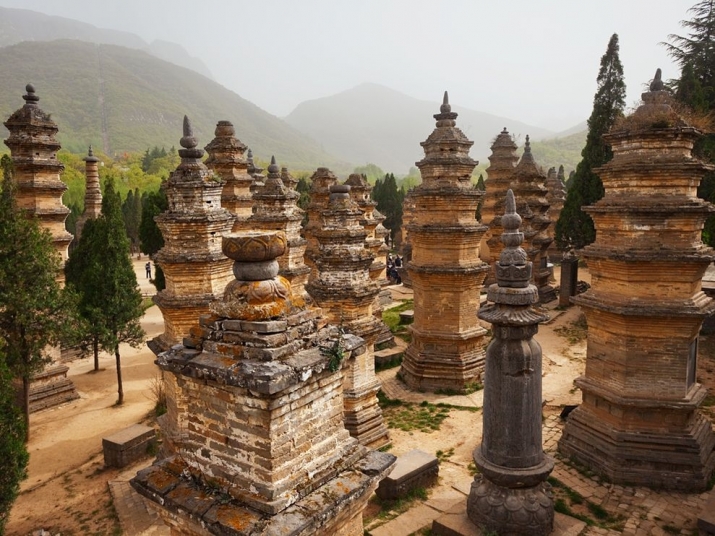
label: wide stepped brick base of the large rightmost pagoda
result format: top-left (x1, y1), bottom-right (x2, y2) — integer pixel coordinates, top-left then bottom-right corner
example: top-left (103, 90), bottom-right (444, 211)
top-left (559, 386), bottom-right (715, 492)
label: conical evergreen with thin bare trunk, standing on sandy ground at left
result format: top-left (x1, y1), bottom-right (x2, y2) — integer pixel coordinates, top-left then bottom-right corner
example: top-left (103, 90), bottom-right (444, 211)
top-left (67, 180), bottom-right (144, 404)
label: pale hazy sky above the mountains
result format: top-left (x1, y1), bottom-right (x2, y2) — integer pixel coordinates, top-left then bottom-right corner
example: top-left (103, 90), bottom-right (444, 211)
top-left (0, 0), bottom-right (696, 131)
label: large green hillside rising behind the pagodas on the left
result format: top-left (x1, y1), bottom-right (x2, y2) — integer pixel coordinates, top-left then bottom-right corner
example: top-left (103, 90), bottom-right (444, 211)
top-left (0, 40), bottom-right (350, 172)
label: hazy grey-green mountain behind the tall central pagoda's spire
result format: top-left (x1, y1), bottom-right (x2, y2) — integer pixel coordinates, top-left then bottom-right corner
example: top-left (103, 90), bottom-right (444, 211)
top-left (285, 84), bottom-right (554, 174)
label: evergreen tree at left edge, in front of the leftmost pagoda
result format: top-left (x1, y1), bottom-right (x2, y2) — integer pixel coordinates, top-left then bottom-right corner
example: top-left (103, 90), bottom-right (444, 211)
top-left (0, 168), bottom-right (77, 437)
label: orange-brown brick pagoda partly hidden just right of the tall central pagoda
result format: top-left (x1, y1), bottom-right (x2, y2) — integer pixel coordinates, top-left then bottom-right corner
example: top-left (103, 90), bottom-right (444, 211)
top-left (482, 127), bottom-right (519, 285)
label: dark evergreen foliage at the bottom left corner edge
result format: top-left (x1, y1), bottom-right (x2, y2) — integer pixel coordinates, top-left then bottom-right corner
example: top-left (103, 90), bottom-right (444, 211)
top-left (0, 348), bottom-right (30, 534)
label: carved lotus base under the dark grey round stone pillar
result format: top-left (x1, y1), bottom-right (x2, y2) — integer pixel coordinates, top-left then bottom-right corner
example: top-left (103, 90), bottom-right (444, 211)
top-left (467, 475), bottom-right (554, 536)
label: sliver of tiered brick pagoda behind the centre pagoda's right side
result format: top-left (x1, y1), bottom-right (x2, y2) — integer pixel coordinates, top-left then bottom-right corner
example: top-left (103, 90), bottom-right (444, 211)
top-left (345, 173), bottom-right (394, 344)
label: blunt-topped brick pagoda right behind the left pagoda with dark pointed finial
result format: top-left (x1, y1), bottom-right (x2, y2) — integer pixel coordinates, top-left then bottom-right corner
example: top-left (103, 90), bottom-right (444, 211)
top-left (204, 121), bottom-right (253, 231)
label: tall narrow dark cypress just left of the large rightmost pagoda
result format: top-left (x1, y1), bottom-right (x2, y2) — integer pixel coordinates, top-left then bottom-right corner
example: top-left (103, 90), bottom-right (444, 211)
top-left (556, 34), bottom-right (626, 251)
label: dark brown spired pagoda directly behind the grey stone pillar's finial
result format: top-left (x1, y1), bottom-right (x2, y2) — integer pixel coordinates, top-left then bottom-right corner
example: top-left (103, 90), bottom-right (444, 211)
top-left (513, 135), bottom-right (557, 303)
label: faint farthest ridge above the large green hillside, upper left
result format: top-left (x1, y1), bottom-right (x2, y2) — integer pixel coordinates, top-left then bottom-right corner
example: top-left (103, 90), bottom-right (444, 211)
top-left (0, 7), bottom-right (213, 80)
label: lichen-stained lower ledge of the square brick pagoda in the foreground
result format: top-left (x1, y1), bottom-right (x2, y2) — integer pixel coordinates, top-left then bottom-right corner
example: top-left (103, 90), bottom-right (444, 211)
top-left (131, 451), bottom-right (395, 536)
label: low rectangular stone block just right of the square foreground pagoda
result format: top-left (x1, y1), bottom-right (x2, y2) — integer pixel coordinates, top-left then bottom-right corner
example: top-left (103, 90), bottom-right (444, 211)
top-left (375, 450), bottom-right (439, 500)
